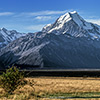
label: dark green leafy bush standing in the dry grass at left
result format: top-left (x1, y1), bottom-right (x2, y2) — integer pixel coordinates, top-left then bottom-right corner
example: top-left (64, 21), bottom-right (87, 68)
top-left (0, 66), bottom-right (24, 94)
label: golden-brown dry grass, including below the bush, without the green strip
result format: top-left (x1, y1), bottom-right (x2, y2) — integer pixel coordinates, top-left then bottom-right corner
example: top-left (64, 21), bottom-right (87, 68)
top-left (0, 77), bottom-right (100, 100)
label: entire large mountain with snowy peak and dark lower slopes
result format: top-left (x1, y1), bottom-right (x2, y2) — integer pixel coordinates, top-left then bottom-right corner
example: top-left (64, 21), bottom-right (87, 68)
top-left (0, 11), bottom-right (100, 69)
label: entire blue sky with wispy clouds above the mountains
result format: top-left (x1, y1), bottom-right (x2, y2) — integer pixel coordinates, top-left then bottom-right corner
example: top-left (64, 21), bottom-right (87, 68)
top-left (0, 0), bottom-right (100, 33)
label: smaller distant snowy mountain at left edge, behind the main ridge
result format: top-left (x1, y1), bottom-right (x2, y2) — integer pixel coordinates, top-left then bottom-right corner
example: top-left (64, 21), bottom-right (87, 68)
top-left (0, 28), bottom-right (25, 48)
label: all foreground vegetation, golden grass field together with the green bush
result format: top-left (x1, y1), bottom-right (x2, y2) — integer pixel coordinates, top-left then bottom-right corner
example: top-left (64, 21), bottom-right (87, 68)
top-left (0, 67), bottom-right (100, 100)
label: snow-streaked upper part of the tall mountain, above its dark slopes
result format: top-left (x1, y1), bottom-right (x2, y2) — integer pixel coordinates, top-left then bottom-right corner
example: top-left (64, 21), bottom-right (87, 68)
top-left (42, 11), bottom-right (100, 39)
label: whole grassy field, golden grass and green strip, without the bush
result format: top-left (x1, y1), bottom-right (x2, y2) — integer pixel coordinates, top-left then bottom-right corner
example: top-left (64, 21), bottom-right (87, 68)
top-left (0, 77), bottom-right (100, 100)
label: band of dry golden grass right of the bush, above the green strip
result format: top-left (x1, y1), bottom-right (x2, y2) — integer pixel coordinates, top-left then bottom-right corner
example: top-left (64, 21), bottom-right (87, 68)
top-left (31, 77), bottom-right (100, 93)
